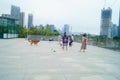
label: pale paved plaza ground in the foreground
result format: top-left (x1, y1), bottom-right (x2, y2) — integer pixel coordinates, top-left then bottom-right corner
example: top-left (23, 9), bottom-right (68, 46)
top-left (0, 39), bottom-right (120, 80)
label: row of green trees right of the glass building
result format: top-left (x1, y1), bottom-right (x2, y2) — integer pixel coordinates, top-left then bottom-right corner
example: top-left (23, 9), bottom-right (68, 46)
top-left (18, 24), bottom-right (59, 37)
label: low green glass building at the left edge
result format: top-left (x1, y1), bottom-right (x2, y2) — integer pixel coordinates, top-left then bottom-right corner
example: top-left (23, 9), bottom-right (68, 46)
top-left (0, 14), bottom-right (18, 38)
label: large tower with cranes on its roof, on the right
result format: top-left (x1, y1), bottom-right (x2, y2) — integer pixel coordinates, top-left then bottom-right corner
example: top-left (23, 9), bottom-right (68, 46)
top-left (100, 7), bottom-right (112, 37)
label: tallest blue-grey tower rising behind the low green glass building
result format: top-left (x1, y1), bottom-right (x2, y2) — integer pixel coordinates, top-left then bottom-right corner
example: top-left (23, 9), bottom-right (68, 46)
top-left (11, 5), bottom-right (20, 20)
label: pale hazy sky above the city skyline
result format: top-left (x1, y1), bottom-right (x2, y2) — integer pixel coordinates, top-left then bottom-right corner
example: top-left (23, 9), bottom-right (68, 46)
top-left (0, 0), bottom-right (120, 34)
